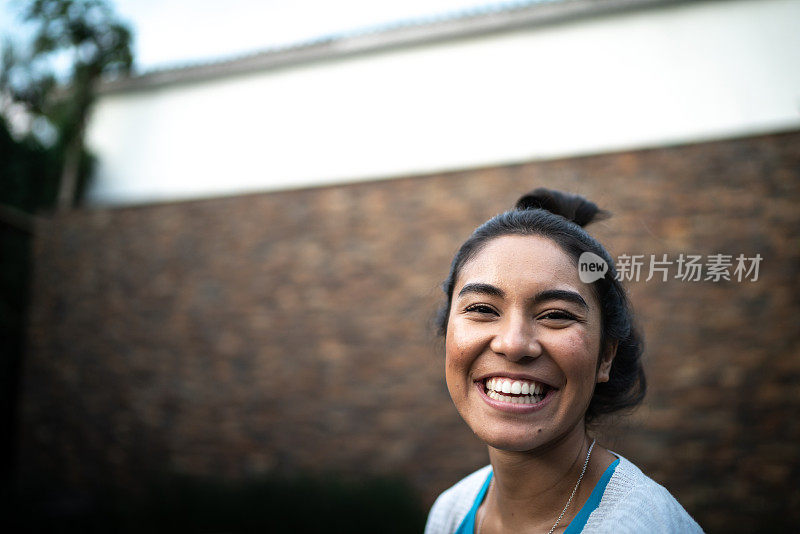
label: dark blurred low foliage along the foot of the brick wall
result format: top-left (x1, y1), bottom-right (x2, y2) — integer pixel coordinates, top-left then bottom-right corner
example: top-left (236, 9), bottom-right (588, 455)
top-left (3, 474), bottom-right (426, 534)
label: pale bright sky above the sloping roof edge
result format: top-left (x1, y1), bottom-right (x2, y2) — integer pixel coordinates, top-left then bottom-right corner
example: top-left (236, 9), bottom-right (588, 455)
top-left (0, 0), bottom-right (550, 72)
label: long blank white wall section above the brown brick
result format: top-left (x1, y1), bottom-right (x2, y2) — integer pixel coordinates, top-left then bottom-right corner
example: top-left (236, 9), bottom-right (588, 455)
top-left (88, 0), bottom-right (800, 204)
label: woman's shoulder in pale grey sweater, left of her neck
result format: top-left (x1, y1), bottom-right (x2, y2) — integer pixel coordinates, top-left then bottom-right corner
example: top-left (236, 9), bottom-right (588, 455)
top-left (425, 465), bottom-right (492, 534)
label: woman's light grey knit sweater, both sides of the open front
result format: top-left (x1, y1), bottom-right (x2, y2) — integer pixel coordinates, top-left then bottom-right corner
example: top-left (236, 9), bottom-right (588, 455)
top-left (425, 455), bottom-right (703, 534)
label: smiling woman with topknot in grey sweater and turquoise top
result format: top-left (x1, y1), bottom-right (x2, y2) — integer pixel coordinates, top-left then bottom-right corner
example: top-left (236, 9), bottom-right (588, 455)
top-left (425, 189), bottom-right (702, 534)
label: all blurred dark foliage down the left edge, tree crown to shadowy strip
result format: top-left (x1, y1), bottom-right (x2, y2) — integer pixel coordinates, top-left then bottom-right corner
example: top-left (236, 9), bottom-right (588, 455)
top-left (0, 0), bottom-right (132, 506)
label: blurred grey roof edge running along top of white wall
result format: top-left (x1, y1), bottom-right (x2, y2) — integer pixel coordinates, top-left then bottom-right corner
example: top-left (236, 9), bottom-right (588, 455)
top-left (99, 0), bottom-right (700, 94)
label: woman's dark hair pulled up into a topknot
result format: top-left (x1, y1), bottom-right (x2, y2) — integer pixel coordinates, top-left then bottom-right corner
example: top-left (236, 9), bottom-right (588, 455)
top-left (436, 188), bottom-right (647, 423)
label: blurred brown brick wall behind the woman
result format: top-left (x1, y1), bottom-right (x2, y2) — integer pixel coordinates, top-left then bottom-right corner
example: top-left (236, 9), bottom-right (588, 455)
top-left (20, 132), bottom-right (800, 532)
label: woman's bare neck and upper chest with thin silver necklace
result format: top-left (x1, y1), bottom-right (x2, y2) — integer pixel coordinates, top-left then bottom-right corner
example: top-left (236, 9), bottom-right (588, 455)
top-left (482, 425), bottom-right (613, 534)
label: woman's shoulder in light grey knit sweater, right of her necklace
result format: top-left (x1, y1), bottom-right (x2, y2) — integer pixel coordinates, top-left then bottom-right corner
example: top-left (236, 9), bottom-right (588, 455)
top-left (584, 455), bottom-right (703, 534)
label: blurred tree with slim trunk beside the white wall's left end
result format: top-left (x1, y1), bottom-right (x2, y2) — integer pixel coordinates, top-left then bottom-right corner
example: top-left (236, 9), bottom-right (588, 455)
top-left (4, 0), bottom-right (133, 209)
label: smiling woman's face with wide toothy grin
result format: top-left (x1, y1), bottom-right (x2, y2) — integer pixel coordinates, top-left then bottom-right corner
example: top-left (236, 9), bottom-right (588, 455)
top-left (445, 236), bottom-right (611, 451)
